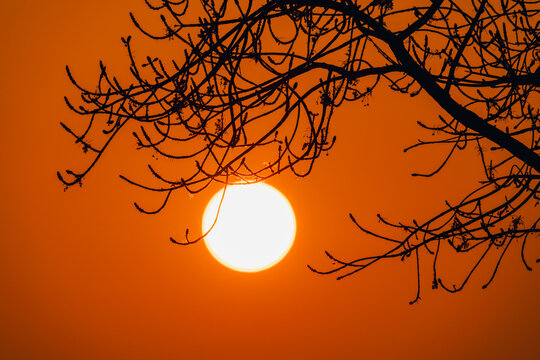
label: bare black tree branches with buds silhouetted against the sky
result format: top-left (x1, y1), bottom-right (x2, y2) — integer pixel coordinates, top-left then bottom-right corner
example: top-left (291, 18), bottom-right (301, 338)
top-left (58, 0), bottom-right (540, 303)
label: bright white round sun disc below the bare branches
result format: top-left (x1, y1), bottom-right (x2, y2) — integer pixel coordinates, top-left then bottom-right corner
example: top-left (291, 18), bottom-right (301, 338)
top-left (203, 183), bottom-right (296, 272)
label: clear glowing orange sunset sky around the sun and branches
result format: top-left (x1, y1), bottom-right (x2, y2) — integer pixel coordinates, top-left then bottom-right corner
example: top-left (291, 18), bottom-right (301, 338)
top-left (0, 0), bottom-right (540, 359)
